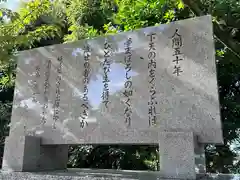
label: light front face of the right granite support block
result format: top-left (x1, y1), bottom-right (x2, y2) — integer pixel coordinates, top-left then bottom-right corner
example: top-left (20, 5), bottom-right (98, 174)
top-left (159, 132), bottom-right (196, 179)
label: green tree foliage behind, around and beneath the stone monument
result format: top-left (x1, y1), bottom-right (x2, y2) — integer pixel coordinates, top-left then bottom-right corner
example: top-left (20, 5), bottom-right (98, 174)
top-left (0, 0), bottom-right (240, 173)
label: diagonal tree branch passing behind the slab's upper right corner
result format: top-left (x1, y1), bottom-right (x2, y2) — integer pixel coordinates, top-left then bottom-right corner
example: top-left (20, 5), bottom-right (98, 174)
top-left (183, 0), bottom-right (240, 58)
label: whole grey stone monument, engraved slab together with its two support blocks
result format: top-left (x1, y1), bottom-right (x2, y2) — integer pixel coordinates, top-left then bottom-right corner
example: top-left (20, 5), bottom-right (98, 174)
top-left (3, 16), bottom-right (223, 179)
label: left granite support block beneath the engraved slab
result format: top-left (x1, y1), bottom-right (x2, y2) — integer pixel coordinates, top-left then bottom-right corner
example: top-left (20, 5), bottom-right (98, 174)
top-left (2, 136), bottom-right (68, 172)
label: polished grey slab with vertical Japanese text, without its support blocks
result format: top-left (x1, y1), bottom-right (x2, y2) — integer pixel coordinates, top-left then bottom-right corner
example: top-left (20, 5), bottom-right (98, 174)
top-left (10, 16), bottom-right (223, 145)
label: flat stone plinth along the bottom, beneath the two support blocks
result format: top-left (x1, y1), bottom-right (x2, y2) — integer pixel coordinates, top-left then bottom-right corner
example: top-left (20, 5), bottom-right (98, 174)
top-left (0, 169), bottom-right (240, 180)
